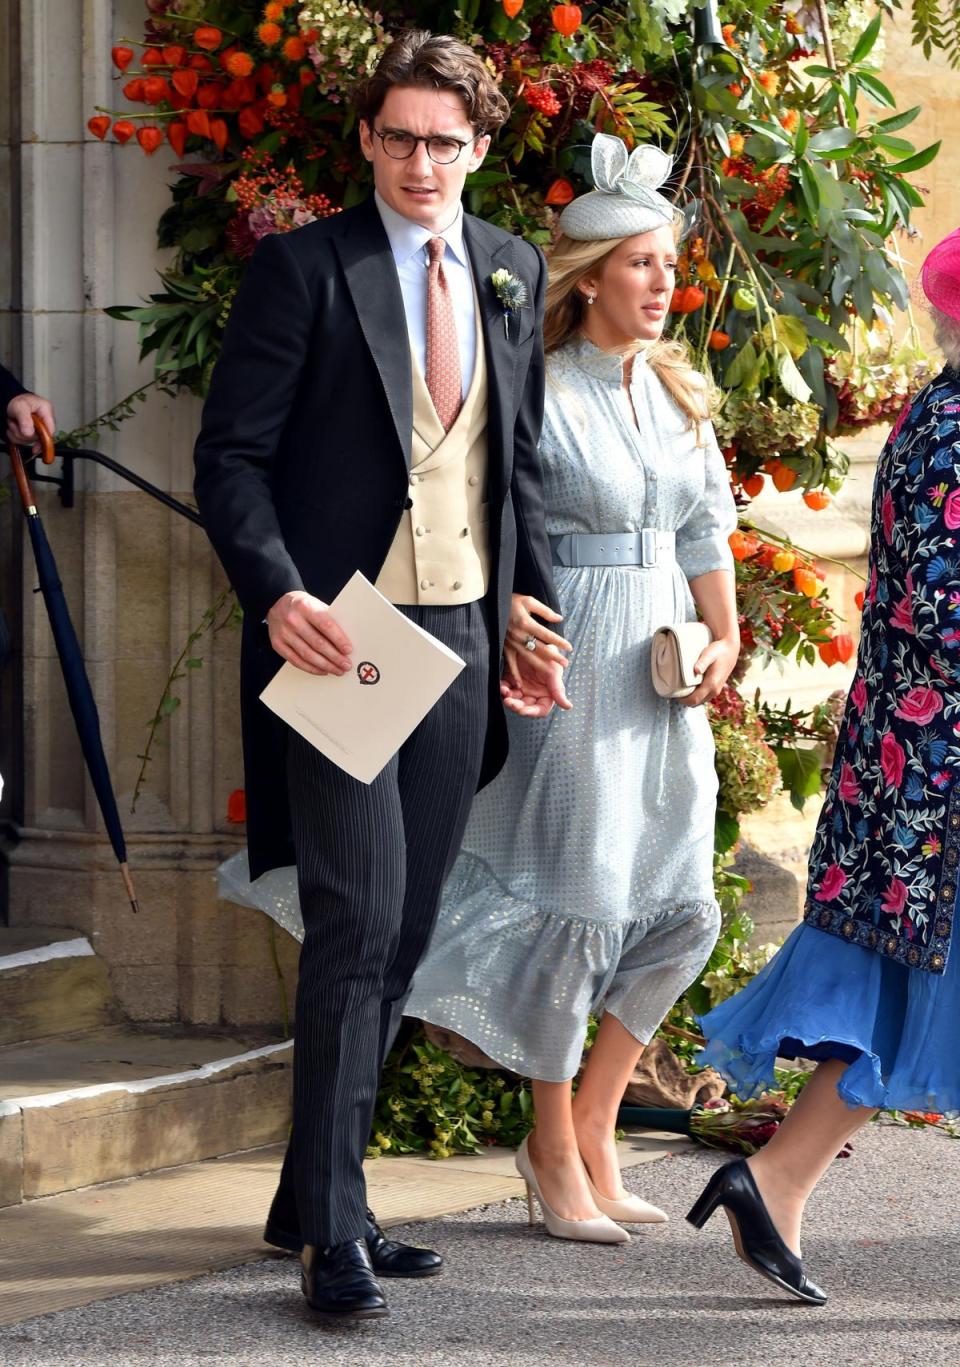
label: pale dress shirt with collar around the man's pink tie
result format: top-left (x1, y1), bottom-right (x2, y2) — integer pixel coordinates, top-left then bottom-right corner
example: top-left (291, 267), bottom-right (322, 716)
top-left (373, 194), bottom-right (477, 398)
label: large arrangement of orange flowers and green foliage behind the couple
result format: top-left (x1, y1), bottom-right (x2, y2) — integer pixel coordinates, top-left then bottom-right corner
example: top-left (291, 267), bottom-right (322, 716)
top-left (89, 0), bottom-right (938, 918)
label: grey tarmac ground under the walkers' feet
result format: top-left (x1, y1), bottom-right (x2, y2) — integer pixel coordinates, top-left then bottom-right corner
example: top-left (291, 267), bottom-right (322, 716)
top-left (0, 1126), bottom-right (960, 1367)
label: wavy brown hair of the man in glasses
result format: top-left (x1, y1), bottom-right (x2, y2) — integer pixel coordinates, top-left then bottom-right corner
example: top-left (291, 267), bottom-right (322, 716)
top-left (353, 29), bottom-right (510, 134)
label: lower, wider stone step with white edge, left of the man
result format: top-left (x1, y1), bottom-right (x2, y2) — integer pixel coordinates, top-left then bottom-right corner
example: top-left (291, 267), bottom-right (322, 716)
top-left (0, 1025), bottom-right (293, 1206)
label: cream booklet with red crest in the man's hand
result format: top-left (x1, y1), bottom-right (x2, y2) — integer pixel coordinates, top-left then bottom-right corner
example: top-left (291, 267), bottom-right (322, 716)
top-left (260, 570), bottom-right (465, 783)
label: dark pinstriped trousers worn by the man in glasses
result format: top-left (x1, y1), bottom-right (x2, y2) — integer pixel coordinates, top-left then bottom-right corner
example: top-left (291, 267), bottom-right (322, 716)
top-left (271, 603), bottom-right (490, 1247)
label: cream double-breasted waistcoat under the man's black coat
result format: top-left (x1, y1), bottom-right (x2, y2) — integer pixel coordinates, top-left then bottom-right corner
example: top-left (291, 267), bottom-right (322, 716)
top-left (376, 302), bottom-right (490, 606)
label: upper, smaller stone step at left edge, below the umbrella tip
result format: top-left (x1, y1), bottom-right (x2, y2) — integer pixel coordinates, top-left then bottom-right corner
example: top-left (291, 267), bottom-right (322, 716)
top-left (0, 925), bottom-right (118, 1044)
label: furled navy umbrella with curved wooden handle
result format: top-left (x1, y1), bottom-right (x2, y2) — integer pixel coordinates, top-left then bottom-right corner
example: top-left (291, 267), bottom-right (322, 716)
top-left (7, 417), bottom-right (139, 912)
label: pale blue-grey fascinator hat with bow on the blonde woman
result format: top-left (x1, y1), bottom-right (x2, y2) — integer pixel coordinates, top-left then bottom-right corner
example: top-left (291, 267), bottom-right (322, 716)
top-left (559, 133), bottom-right (697, 242)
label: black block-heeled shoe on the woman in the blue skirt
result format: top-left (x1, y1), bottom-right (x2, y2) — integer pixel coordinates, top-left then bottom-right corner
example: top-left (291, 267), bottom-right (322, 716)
top-left (686, 1158), bottom-right (826, 1305)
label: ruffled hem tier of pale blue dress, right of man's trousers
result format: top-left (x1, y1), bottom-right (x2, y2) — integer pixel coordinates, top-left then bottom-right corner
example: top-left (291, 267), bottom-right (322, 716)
top-left (403, 853), bottom-right (719, 1083)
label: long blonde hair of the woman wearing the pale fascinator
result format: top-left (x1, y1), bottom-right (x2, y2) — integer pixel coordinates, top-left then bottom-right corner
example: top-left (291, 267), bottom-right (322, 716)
top-left (543, 224), bottom-right (717, 446)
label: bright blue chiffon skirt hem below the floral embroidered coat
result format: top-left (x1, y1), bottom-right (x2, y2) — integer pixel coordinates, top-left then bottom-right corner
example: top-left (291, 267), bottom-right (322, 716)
top-left (697, 902), bottom-right (960, 1115)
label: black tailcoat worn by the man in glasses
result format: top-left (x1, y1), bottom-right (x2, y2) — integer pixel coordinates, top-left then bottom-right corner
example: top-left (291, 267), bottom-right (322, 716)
top-left (194, 200), bottom-right (557, 878)
